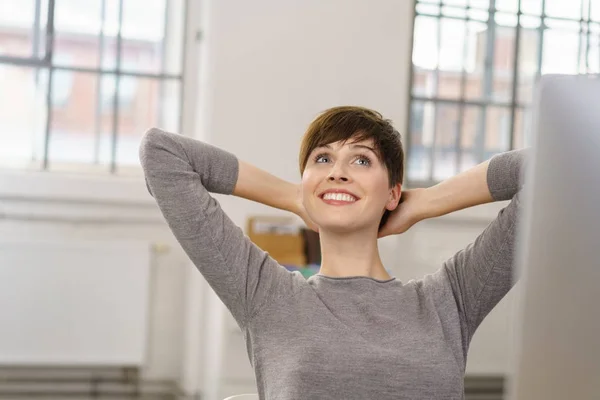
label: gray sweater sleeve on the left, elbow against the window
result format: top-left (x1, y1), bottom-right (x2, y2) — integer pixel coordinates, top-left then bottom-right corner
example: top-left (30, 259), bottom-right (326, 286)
top-left (139, 129), bottom-right (295, 328)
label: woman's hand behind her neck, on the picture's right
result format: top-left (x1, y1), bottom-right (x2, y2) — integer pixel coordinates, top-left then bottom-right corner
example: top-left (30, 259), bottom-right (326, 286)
top-left (377, 189), bottom-right (427, 238)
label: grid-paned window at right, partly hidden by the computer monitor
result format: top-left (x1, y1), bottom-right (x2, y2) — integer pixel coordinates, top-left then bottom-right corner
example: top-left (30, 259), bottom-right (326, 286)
top-left (406, 0), bottom-right (600, 186)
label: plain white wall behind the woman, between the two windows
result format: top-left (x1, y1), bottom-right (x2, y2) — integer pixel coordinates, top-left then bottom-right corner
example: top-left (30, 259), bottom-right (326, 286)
top-left (192, 0), bottom-right (520, 399)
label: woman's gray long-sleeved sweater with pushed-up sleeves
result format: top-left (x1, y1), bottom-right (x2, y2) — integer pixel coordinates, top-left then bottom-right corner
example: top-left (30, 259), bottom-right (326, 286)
top-left (140, 129), bottom-right (525, 400)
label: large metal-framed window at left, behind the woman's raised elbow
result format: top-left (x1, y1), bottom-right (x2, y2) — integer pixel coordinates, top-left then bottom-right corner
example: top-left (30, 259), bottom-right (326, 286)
top-left (0, 0), bottom-right (187, 173)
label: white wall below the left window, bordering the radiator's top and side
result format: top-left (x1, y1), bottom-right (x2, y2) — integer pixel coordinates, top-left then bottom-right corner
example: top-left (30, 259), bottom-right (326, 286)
top-left (0, 173), bottom-right (188, 380)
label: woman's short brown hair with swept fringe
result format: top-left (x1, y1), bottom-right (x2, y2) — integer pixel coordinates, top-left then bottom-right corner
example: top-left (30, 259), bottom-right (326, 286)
top-left (299, 106), bottom-right (404, 227)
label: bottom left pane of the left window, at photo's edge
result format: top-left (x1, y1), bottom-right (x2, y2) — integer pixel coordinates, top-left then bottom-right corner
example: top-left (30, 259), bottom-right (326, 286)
top-left (0, 64), bottom-right (48, 168)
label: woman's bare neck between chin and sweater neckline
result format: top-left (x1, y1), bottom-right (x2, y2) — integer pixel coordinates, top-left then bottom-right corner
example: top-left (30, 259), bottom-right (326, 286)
top-left (319, 227), bottom-right (391, 280)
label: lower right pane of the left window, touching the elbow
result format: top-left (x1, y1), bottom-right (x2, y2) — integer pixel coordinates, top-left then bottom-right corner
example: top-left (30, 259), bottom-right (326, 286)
top-left (117, 77), bottom-right (181, 166)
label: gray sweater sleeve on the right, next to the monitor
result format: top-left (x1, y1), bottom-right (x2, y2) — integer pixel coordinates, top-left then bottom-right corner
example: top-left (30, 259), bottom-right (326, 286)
top-left (442, 150), bottom-right (528, 343)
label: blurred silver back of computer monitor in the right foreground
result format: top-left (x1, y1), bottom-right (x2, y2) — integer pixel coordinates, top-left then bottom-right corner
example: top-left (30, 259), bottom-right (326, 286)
top-left (506, 75), bottom-right (600, 400)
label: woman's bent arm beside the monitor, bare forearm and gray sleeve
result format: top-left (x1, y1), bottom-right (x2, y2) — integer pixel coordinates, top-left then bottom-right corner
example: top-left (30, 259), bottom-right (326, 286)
top-left (424, 150), bottom-right (529, 340)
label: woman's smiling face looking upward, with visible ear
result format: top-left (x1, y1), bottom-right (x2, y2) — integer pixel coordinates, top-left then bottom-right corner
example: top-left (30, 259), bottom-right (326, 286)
top-left (302, 139), bottom-right (400, 233)
